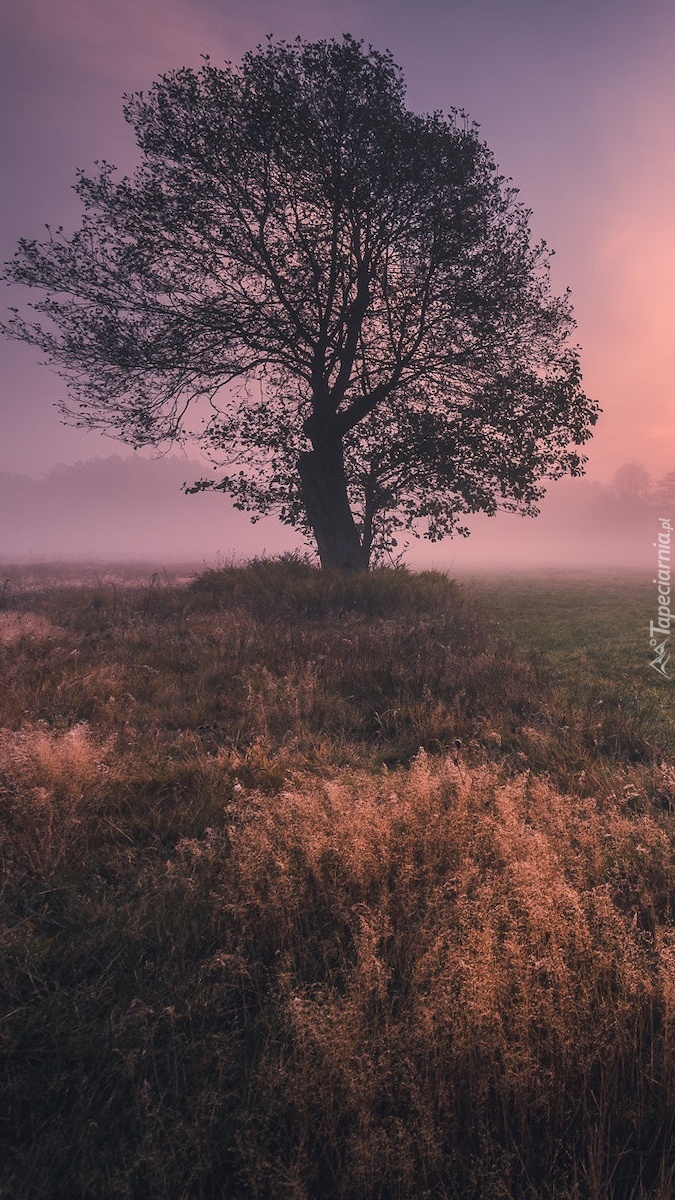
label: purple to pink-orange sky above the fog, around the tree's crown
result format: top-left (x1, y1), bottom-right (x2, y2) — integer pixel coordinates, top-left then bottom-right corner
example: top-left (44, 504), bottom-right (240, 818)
top-left (0, 0), bottom-right (675, 559)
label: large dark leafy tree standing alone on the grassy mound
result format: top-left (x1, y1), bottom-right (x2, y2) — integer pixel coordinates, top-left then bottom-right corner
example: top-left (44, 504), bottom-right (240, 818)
top-left (5, 36), bottom-right (598, 569)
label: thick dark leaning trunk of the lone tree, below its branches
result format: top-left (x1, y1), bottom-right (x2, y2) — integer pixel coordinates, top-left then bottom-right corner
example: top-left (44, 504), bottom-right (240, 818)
top-left (298, 440), bottom-right (369, 571)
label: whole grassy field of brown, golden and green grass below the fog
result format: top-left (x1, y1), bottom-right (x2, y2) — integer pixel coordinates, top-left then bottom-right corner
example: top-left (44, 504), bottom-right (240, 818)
top-left (0, 560), bottom-right (675, 1200)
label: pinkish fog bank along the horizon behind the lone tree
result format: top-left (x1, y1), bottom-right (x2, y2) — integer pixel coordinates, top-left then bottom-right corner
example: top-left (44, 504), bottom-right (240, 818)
top-left (0, 455), bottom-right (662, 571)
